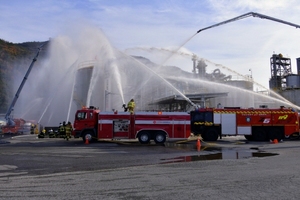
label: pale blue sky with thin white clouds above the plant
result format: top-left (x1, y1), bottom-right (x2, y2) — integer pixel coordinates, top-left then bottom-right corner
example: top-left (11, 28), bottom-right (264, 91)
top-left (0, 0), bottom-right (300, 86)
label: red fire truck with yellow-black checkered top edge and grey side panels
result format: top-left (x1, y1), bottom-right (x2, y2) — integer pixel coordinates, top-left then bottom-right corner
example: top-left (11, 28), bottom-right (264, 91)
top-left (191, 107), bottom-right (299, 141)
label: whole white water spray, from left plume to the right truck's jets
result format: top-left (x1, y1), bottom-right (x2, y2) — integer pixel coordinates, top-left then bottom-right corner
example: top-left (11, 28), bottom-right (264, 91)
top-left (9, 21), bottom-right (300, 126)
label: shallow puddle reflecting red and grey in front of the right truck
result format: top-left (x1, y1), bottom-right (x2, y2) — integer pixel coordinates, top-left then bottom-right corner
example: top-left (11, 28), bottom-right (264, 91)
top-left (161, 148), bottom-right (279, 164)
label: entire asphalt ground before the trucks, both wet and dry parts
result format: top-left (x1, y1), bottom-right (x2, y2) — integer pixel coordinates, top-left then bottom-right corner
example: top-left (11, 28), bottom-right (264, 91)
top-left (0, 135), bottom-right (300, 200)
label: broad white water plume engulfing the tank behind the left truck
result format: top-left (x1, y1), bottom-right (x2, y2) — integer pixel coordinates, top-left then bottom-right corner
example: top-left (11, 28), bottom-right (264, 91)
top-left (11, 23), bottom-right (183, 126)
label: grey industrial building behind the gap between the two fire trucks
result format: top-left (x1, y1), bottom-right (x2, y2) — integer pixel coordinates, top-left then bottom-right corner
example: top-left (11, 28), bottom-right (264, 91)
top-left (149, 55), bottom-right (254, 111)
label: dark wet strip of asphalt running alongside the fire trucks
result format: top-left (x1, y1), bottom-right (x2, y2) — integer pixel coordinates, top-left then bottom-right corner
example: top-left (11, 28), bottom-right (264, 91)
top-left (0, 134), bottom-right (292, 177)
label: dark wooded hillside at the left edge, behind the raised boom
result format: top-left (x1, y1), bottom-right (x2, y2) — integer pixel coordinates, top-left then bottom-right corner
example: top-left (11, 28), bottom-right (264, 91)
top-left (0, 39), bottom-right (47, 113)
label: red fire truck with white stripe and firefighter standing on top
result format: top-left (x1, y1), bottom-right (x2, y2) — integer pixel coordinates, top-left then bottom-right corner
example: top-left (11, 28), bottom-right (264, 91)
top-left (72, 107), bottom-right (191, 144)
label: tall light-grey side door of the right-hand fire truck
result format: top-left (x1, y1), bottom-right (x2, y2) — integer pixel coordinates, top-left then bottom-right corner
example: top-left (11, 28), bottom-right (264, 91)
top-left (221, 114), bottom-right (236, 135)
